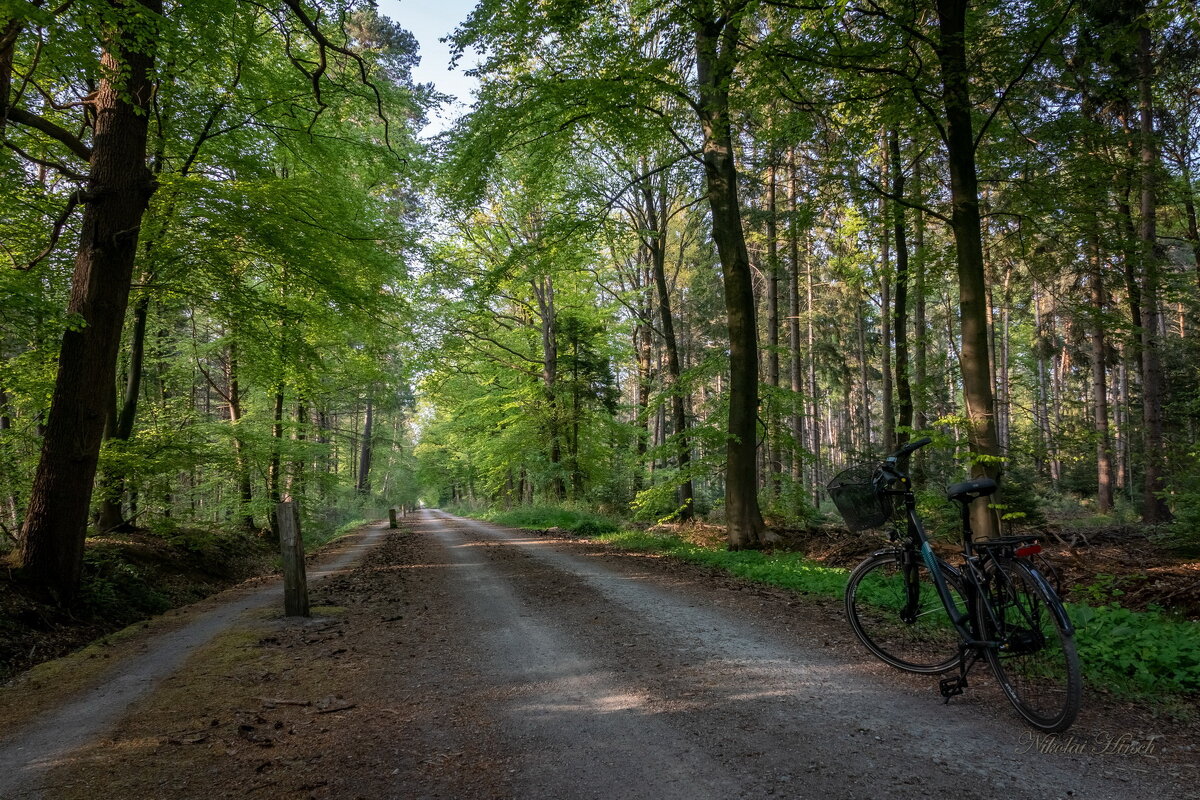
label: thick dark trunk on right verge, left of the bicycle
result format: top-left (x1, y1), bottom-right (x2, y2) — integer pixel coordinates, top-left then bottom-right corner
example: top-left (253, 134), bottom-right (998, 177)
top-left (696, 10), bottom-right (773, 549)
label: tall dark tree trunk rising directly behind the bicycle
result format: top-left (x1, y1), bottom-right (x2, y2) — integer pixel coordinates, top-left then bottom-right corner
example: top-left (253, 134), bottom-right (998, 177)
top-left (935, 0), bottom-right (1001, 539)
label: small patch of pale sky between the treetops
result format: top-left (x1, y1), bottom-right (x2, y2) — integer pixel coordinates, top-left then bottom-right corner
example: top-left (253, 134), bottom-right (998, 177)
top-left (378, 0), bottom-right (478, 136)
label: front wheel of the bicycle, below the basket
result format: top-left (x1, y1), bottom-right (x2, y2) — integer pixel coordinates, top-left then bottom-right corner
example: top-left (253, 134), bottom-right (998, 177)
top-left (845, 551), bottom-right (965, 674)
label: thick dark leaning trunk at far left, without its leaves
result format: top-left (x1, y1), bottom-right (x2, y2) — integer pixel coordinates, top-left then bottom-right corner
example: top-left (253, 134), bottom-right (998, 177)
top-left (22, 0), bottom-right (162, 597)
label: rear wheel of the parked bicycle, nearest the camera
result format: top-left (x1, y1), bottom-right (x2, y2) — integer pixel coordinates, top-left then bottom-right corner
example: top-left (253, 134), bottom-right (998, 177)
top-left (976, 558), bottom-right (1082, 733)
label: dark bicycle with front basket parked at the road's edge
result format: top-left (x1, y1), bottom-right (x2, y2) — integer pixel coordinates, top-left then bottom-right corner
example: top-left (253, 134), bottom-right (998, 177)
top-left (828, 437), bottom-right (1082, 733)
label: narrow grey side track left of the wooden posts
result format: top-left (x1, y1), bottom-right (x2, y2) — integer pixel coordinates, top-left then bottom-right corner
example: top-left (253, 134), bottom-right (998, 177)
top-left (0, 525), bottom-right (383, 800)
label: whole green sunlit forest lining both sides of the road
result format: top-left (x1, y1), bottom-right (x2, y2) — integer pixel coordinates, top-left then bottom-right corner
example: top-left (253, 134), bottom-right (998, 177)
top-left (0, 0), bottom-right (1200, 597)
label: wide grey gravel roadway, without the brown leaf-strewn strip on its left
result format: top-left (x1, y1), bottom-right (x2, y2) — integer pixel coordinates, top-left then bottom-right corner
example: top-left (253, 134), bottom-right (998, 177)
top-left (418, 512), bottom-right (1192, 800)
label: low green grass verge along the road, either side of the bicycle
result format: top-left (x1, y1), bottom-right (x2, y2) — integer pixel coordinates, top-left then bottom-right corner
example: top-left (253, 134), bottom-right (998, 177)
top-left (595, 531), bottom-right (1200, 700)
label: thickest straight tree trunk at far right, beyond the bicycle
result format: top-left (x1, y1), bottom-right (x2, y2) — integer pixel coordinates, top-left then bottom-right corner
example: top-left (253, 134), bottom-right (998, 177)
top-left (1138, 18), bottom-right (1171, 524)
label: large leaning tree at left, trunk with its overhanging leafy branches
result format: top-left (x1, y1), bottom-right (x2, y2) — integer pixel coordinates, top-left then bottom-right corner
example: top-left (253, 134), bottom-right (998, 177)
top-left (0, 0), bottom-right (420, 597)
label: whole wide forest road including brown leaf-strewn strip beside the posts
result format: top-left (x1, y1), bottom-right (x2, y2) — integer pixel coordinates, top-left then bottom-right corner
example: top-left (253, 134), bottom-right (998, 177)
top-left (0, 512), bottom-right (1200, 800)
